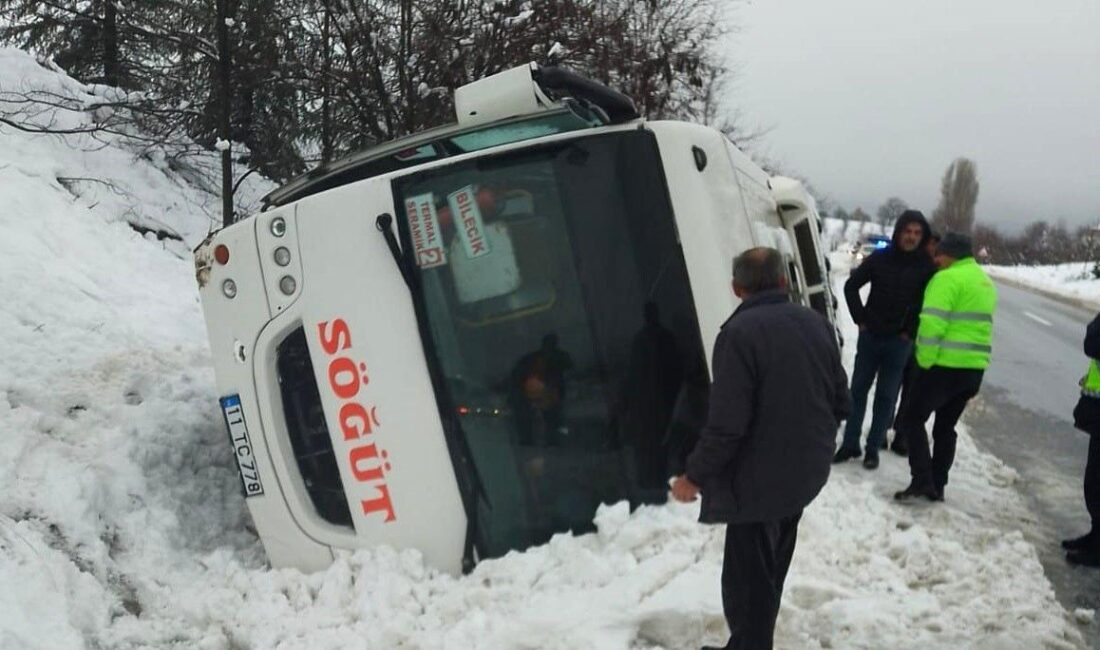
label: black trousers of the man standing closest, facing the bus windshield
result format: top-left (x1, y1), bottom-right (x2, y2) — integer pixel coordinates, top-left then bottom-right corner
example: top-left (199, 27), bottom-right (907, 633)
top-left (722, 510), bottom-right (802, 650)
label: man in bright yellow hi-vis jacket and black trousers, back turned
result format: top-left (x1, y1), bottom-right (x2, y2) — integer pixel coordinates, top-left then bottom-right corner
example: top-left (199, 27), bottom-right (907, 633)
top-left (894, 233), bottom-right (997, 502)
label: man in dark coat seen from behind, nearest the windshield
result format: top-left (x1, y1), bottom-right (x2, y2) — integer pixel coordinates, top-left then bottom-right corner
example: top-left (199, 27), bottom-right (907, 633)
top-left (672, 249), bottom-right (849, 650)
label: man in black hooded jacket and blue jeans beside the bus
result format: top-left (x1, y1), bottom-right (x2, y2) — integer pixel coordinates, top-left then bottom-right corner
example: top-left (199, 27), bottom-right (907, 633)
top-left (833, 210), bottom-right (936, 470)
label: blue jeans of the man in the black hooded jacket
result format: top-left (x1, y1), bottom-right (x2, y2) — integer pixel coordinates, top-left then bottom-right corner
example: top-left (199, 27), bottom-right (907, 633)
top-left (842, 331), bottom-right (913, 455)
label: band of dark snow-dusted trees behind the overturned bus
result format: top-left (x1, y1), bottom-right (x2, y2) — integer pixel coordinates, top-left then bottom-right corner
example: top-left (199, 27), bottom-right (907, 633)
top-left (0, 0), bottom-right (754, 227)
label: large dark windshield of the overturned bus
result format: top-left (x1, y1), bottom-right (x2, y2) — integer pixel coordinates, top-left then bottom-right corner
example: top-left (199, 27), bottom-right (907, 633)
top-left (394, 130), bottom-right (707, 557)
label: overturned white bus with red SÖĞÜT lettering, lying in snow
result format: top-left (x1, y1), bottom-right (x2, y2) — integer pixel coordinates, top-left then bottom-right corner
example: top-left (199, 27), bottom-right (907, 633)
top-left (195, 65), bottom-right (835, 572)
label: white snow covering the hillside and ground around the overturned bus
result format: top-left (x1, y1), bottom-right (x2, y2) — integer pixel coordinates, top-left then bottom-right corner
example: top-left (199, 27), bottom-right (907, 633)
top-left (0, 49), bottom-right (1081, 650)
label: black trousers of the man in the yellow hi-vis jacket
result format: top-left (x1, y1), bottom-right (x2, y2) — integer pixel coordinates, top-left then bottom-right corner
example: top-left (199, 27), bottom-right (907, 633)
top-left (898, 366), bottom-right (985, 489)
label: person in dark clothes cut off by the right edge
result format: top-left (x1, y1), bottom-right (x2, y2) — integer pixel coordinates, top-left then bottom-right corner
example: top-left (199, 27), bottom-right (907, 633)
top-left (1062, 315), bottom-right (1100, 566)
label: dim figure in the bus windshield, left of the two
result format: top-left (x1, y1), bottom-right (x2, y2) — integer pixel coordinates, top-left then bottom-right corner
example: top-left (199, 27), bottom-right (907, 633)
top-left (509, 332), bottom-right (573, 447)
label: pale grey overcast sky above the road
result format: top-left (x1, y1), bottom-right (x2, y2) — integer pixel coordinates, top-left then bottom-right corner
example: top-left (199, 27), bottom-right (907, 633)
top-left (730, 0), bottom-right (1100, 228)
